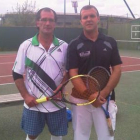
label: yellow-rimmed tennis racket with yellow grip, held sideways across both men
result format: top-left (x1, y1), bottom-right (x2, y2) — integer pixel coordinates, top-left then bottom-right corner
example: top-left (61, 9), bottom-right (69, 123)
top-left (36, 75), bottom-right (100, 106)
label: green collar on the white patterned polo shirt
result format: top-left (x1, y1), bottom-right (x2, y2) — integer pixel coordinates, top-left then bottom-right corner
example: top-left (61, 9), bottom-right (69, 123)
top-left (32, 34), bottom-right (59, 46)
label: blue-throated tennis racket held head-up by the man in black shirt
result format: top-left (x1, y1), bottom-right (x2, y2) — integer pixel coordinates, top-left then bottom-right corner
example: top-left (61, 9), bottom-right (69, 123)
top-left (88, 66), bottom-right (114, 136)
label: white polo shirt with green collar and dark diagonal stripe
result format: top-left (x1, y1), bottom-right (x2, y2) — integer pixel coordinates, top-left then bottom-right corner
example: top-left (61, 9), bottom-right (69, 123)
top-left (13, 35), bottom-right (68, 112)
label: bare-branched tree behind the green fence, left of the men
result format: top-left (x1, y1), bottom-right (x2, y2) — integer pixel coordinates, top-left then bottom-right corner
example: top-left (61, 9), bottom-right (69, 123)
top-left (4, 0), bottom-right (36, 27)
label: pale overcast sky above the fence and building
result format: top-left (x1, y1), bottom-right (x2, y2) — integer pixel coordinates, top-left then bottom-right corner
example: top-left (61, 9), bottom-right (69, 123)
top-left (0, 0), bottom-right (140, 18)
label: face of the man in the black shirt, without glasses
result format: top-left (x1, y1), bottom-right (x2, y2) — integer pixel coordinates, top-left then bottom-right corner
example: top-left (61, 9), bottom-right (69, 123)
top-left (81, 8), bottom-right (100, 32)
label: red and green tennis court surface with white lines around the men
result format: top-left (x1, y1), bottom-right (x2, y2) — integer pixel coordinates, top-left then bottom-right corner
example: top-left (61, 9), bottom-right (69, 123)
top-left (0, 50), bottom-right (140, 140)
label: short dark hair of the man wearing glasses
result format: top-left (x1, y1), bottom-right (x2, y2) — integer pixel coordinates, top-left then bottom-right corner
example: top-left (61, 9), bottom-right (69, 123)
top-left (36, 7), bottom-right (57, 22)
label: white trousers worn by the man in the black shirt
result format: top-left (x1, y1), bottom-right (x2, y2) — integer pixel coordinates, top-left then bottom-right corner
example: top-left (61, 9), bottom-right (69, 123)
top-left (72, 100), bottom-right (117, 140)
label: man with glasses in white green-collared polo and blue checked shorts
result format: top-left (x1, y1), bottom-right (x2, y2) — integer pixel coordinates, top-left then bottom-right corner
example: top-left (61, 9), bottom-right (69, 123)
top-left (13, 8), bottom-right (67, 140)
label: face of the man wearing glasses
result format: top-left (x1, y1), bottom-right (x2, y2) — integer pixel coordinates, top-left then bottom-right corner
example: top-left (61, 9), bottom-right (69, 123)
top-left (36, 11), bottom-right (55, 34)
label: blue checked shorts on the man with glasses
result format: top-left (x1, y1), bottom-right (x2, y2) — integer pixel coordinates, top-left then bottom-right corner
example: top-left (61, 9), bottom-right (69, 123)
top-left (21, 108), bottom-right (68, 136)
